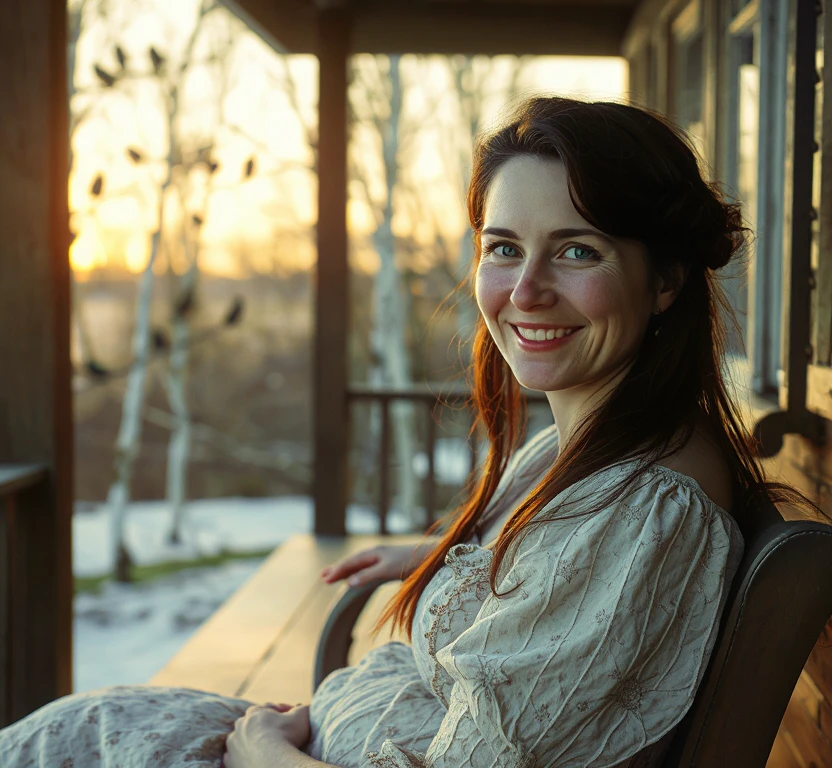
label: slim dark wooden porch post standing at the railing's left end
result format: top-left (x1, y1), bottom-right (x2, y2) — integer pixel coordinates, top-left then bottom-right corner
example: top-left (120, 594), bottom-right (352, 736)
top-left (312, 8), bottom-right (351, 536)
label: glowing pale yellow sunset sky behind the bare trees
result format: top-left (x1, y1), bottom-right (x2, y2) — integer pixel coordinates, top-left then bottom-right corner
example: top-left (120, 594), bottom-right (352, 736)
top-left (69, 0), bottom-right (627, 279)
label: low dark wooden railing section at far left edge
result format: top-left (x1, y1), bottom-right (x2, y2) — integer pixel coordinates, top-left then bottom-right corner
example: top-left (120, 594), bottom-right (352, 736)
top-left (0, 465), bottom-right (50, 728)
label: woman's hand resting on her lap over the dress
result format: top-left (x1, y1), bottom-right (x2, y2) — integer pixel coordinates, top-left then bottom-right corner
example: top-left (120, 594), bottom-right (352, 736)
top-left (223, 704), bottom-right (310, 768)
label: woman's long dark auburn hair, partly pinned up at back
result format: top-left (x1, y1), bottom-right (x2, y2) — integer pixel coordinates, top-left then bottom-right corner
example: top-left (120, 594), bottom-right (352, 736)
top-left (376, 97), bottom-right (814, 636)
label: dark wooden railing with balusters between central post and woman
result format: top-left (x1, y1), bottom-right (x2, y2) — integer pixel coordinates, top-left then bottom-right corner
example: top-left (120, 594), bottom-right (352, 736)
top-left (347, 384), bottom-right (547, 534)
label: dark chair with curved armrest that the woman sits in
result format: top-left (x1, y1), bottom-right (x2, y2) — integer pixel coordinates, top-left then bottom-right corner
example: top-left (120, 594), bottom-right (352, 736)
top-left (314, 505), bottom-right (832, 768)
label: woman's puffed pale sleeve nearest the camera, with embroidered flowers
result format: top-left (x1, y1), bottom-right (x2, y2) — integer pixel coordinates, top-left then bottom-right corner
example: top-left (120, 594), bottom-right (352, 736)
top-left (368, 472), bottom-right (742, 768)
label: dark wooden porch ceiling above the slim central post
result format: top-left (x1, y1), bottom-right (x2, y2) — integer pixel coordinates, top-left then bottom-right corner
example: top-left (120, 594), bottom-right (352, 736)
top-left (223, 0), bottom-right (639, 56)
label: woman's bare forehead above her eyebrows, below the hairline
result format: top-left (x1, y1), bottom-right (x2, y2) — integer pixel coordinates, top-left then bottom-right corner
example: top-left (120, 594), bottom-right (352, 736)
top-left (483, 155), bottom-right (588, 231)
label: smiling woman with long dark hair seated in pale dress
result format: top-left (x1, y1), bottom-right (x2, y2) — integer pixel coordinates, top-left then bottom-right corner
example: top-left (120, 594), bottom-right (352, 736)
top-left (0, 98), bottom-right (820, 768)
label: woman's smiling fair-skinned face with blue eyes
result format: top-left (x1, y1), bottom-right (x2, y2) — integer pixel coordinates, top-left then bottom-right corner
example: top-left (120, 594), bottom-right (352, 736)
top-left (476, 156), bottom-right (658, 392)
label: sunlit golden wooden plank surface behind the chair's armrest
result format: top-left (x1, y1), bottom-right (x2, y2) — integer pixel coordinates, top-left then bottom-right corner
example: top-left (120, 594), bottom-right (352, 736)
top-left (150, 534), bottom-right (419, 704)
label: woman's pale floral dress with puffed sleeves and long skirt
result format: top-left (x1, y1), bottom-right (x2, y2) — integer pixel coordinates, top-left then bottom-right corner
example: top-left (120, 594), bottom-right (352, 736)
top-left (0, 428), bottom-right (743, 768)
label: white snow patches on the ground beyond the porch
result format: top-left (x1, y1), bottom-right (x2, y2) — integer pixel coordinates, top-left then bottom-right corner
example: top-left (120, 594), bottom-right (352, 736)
top-left (73, 497), bottom-right (406, 691)
